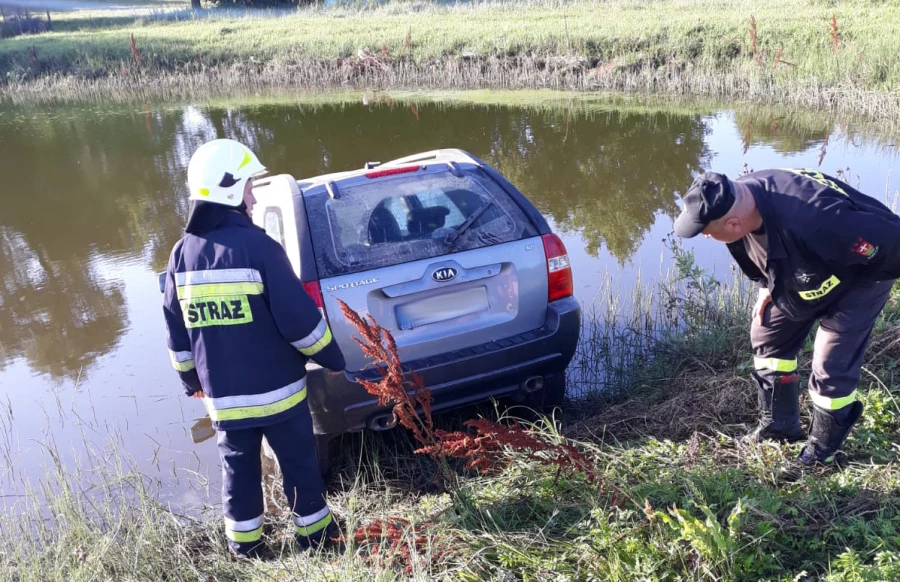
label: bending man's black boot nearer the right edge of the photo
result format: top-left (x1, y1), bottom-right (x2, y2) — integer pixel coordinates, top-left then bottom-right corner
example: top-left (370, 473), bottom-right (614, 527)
top-left (782, 400), bottom-right (863, 480)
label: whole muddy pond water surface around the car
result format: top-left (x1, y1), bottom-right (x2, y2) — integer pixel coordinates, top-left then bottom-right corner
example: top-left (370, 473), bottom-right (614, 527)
top-left (0, 97), bottom-right (900, 505)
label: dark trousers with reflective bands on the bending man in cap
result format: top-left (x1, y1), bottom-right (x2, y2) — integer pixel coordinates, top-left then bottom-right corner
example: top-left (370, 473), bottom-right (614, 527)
top-left (750, 280), bottom-right (894, 420)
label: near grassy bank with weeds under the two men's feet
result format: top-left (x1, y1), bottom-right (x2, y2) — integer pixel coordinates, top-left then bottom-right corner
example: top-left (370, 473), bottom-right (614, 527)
top-left (0, 243), bottom-right (900, 581)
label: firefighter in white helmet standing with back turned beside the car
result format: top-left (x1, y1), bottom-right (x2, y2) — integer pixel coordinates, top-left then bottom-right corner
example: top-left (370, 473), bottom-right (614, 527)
top-left (163, 139), bottom-right (345, 557)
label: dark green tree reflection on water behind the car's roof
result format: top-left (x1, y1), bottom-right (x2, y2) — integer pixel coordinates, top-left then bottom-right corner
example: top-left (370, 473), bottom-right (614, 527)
top-left (202, 102), bottom-right (706, 261)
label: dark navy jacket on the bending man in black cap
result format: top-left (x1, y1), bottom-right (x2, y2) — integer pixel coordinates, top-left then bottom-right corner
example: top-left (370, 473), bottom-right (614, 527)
top-left (728, 170), bottom-right (900, 321)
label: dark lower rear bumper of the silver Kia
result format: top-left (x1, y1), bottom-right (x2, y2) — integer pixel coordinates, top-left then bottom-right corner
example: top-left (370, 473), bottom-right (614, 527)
top-left (307, 297), bottom-right (581, 435)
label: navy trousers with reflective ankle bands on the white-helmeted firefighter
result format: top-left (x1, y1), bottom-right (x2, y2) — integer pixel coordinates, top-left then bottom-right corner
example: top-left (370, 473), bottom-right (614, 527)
top-left (218, 401), bottom-right (332, 554)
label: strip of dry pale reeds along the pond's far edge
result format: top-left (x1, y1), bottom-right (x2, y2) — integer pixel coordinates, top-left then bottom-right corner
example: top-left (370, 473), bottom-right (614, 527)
top-left (0, 56), bottom-right (900, 119)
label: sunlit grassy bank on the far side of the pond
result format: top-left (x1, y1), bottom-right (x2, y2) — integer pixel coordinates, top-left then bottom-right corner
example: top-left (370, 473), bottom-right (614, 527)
top-left (0, 0), bottom-right (900, 113)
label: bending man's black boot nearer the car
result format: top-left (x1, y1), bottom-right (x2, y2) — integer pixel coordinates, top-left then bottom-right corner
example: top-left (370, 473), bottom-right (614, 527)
top-left (740, 374), bottom-right (806, 443)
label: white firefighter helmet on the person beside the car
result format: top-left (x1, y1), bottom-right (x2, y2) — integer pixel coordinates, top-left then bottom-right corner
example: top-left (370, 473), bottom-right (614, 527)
top-left (188, 139), bottom-right (266, 206)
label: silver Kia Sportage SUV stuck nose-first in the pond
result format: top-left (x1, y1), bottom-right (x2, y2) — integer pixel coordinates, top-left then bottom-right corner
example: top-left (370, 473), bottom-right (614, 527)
top-left (163, 149), bottom-right (581, 474)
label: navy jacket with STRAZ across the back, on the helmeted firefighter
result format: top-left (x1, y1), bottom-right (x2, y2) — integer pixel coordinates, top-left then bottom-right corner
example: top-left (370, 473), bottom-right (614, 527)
top-left (163, 212), bottom-right (345, 430)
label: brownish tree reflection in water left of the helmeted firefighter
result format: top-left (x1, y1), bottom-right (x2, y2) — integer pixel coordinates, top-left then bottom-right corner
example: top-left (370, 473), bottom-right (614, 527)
top-left (0, 112), bottom-right (192, 379)
